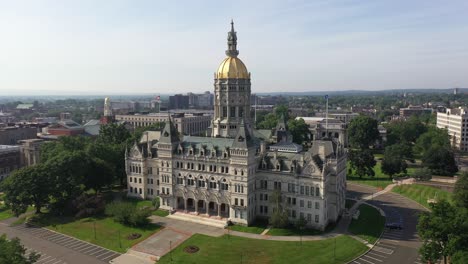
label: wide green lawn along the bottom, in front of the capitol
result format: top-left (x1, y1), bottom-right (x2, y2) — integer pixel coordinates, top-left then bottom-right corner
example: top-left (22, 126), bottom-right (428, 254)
top-left (158, 234), bottom-right (367, 264)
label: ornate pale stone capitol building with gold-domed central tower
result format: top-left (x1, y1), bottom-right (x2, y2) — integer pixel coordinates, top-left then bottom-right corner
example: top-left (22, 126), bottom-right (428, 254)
top-left (125, 22), bottom-right (347, 230)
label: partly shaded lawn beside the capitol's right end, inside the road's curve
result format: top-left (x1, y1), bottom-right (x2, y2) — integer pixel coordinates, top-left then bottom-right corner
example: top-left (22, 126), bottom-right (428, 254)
top-left (349, 204), bottom-right (385, 244)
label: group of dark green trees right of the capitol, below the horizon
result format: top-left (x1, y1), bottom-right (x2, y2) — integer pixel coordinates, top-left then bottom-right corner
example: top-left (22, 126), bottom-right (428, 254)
top-left (348, 115), bottom-right (458, 177)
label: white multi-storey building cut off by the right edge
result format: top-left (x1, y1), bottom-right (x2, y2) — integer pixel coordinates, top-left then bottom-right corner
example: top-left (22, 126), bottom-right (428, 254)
top-left (437, 107), bottom-right (468, 151)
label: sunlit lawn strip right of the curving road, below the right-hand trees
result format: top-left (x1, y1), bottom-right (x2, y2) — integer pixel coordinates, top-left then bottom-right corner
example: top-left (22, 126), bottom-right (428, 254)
top-left (392, 184), bottom-right (452, 208)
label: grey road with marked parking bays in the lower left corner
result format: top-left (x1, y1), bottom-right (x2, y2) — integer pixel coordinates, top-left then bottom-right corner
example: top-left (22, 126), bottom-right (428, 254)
top-left (0, 222), bottom-right (113, 264)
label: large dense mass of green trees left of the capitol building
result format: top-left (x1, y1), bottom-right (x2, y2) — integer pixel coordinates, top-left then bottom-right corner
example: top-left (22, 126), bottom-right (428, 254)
top-left (0, 123), bottom-right (163, 215)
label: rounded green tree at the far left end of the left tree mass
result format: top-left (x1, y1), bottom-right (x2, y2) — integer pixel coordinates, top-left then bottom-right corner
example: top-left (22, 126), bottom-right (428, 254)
top-left (2, 164), bottom-right (51, 216)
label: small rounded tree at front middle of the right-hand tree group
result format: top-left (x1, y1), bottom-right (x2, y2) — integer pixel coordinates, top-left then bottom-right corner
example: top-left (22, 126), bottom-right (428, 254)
top-left (382, 144), bottom-right (408, 178)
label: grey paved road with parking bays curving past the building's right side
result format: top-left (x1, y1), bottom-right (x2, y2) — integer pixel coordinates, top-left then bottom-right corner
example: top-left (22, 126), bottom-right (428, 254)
top-left (347, 182), bottom-right (426, 264)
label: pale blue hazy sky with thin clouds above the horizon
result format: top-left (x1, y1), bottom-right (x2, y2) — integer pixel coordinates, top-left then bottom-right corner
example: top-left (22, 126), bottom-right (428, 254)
top-left (0, 0), bottom-right (468, 96)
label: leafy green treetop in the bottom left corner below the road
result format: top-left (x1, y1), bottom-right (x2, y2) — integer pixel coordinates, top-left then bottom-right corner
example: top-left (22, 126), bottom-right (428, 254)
top-left (0, 234), bottom-right (41, 264)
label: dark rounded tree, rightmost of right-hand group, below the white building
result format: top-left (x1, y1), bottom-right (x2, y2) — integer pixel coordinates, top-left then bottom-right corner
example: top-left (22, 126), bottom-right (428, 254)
top-left (422, 145), bottom-right (458, 176)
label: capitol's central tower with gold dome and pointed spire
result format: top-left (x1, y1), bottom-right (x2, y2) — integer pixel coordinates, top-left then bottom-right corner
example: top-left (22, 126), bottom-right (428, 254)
top-left (211, 21), bottom-right (252, 138)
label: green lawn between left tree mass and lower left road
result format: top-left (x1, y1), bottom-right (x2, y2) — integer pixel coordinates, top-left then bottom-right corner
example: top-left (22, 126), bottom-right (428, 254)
top-left (33, 215), bottom-right (161, 252)
